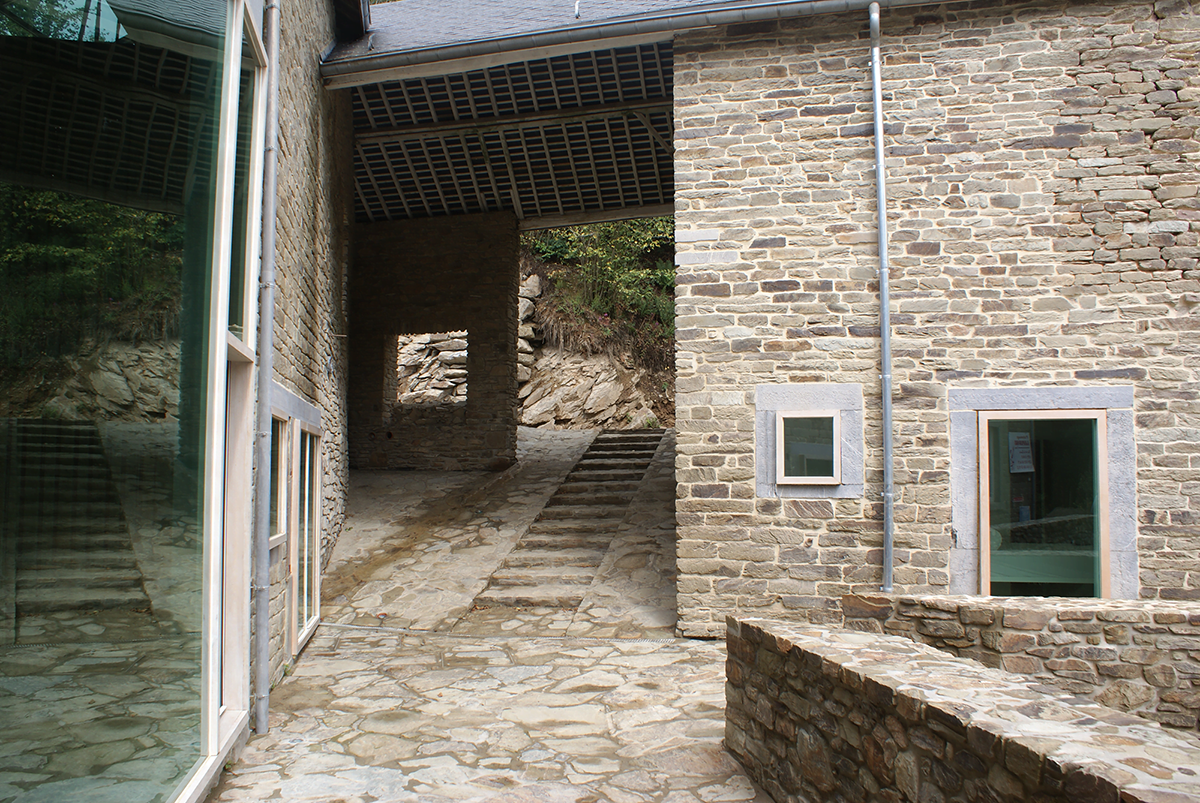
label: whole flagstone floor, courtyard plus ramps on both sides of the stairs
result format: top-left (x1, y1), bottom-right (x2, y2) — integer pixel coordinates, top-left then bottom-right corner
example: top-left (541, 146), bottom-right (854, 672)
top-left (210, 429), bottom-right (769, 803)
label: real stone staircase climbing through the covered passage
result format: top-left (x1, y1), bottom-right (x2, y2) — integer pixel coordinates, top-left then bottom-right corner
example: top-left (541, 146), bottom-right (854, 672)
top-left (475, 430), bottom-right (664, 609)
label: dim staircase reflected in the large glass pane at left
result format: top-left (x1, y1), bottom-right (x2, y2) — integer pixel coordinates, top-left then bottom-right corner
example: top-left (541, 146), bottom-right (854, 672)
top-left (10, 419), bottom-right (150, 621)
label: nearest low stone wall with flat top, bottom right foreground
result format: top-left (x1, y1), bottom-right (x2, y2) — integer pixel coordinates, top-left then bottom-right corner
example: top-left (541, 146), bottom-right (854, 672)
top-left (725, 618), bottom-right (1200, 803)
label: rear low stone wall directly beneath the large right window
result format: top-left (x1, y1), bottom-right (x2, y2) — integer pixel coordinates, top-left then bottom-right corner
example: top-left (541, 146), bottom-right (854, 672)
top-left (842, 594), bottom-right (1200, 730)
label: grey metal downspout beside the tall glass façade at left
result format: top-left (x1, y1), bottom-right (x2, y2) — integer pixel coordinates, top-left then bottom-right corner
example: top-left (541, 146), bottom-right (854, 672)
top-left (253, 0), bottom-right (280, 733)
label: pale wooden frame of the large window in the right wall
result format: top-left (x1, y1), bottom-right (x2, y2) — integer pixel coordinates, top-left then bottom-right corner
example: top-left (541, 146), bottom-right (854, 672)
top-left (977, 409), bottom-right (1112, 599)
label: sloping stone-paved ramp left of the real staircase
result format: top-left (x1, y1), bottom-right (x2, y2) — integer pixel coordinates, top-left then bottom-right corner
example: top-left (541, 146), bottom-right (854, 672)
top-left (322, 427), bottom-right (595, 630)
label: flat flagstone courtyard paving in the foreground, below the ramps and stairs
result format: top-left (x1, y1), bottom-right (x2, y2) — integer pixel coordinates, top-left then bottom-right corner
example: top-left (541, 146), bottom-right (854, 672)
top-left (211, 625), bottom-right (769, 803)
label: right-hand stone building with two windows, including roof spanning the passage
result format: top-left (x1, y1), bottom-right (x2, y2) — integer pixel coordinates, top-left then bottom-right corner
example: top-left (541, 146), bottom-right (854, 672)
top-left (324, 2), bottom-right (1200, 635)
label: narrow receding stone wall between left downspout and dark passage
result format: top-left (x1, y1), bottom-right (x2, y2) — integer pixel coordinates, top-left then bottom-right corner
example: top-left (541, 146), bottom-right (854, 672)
top-left (266, 0), bottom-right (353, 677)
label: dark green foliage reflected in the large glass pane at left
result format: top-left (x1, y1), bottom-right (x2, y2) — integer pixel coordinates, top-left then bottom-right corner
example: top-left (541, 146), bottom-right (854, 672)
top-left (0, 184), bottom-right (184, 365)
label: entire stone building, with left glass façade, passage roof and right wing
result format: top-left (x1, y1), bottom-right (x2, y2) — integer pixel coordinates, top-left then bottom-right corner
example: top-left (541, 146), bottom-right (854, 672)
top-left (0, 0), bottom-right (1200, 801)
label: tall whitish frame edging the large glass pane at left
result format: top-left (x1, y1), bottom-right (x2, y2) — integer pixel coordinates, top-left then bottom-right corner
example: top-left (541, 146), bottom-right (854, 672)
top-left (176, 0), bottom-right (266, 803)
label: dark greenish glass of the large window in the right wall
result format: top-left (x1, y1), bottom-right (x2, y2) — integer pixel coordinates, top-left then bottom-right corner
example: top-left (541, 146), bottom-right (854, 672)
top-left (986, 419), bottom-right (1100, 597)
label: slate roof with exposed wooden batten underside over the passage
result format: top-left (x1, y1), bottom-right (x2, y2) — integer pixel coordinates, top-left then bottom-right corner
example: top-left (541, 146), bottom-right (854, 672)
top-left (323, 0), bottom-right (907, 228)
